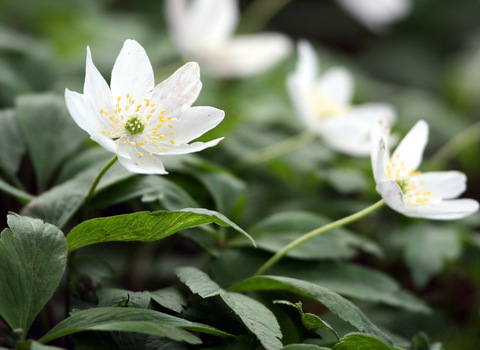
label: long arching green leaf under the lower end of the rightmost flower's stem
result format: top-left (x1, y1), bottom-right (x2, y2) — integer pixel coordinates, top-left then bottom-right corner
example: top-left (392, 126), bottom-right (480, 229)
top-left (230, 276), bottom-right (391, 342)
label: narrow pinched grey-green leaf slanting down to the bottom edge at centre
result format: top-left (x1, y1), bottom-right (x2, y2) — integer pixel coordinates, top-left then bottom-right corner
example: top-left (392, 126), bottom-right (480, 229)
top-left (177, 267), bottom-right (283, 350)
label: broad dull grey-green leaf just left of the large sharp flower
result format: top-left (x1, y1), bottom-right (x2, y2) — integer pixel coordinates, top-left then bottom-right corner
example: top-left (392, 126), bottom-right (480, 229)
top-left (16, 93), bottom-right (87, 191)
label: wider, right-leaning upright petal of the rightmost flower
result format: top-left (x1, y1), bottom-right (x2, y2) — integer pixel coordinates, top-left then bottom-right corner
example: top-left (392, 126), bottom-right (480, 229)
top-left (392, 120), bottom-right (428, 173)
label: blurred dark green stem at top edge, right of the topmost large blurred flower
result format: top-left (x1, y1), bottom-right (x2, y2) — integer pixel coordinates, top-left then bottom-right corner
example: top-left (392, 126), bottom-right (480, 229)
top-left (239, 0), bottom-right (292, 33)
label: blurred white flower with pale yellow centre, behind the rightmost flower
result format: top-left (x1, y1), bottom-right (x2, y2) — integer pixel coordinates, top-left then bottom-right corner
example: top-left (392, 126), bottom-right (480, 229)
top-left (287, 41), bottom-right (395, 156)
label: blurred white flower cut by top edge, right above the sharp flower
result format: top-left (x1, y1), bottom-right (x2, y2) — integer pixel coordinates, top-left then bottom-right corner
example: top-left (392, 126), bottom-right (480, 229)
top-left (167, 0), bottom-right (292, 78)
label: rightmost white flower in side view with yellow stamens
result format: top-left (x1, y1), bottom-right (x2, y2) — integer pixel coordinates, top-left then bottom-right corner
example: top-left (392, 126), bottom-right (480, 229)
top-left (372, 119), bottom-right (478, 220)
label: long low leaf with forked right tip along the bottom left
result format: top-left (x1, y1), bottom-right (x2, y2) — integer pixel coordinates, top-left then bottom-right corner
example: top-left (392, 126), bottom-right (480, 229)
top-left (39, 307), bottom-right (231, 344)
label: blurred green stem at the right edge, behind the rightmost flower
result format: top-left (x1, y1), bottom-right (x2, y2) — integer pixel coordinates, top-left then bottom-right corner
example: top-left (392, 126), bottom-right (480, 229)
top-left (424, 122), bottom-right (480, 169)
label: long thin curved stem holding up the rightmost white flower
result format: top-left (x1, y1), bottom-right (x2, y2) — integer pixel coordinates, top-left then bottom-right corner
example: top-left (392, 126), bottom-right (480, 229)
top-left (254, 199), bottom-right (385, 276)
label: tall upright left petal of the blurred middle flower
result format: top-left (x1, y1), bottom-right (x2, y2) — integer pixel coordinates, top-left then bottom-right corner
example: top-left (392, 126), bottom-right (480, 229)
top-left (286, 40), bottom-right (318, 128)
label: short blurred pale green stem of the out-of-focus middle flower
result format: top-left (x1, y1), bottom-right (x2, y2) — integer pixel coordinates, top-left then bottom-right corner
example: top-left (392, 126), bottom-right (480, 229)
top-left (233, 130), bottom-right (317, 171)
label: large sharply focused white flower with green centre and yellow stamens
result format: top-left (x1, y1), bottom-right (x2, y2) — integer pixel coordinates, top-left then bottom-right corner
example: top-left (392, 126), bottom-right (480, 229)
top-left (65, 40), bottom-right (224, 174)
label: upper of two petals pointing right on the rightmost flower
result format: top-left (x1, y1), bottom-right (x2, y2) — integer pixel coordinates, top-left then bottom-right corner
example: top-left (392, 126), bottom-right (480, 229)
top-left (415, 171), bottom-right (467, 199)
